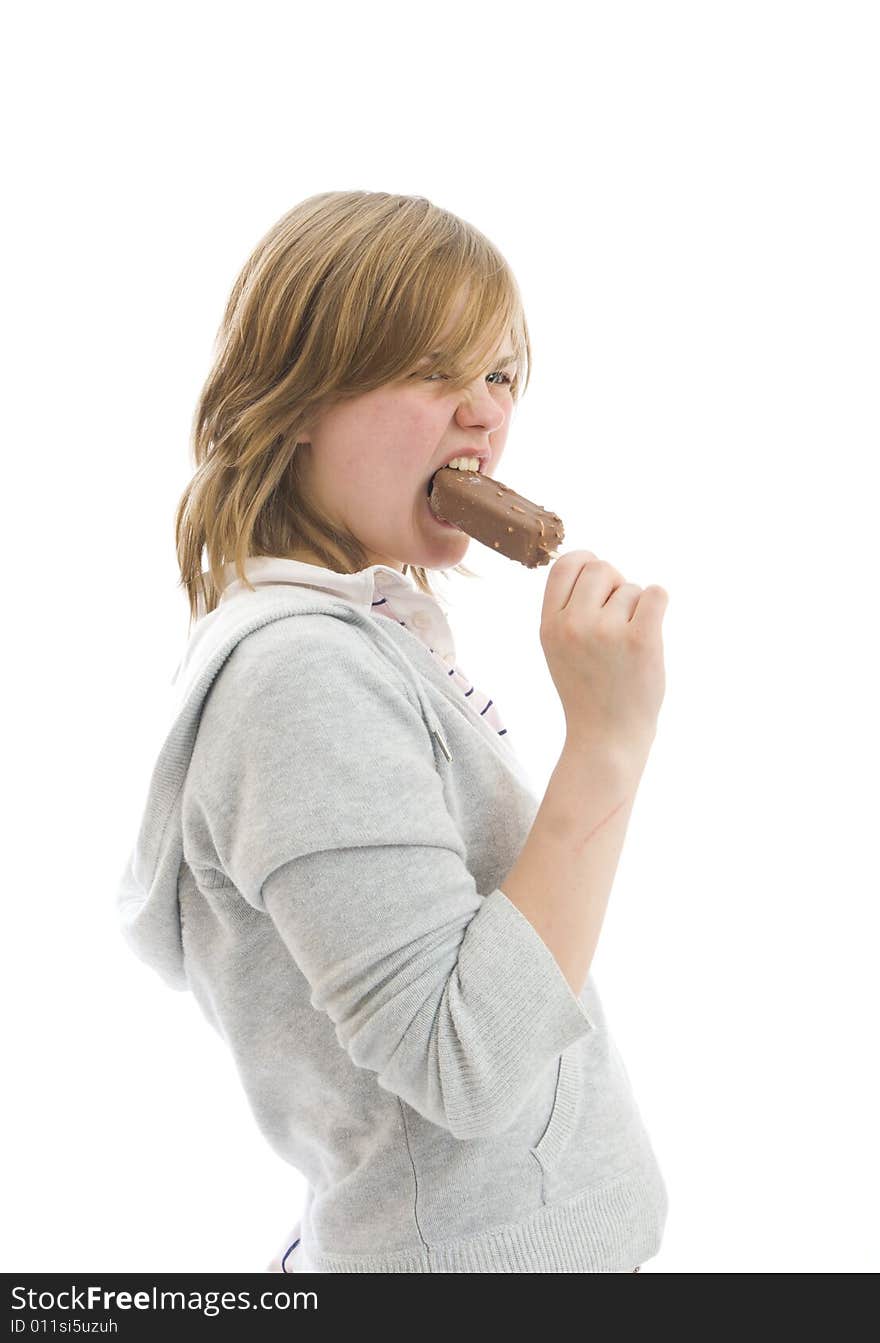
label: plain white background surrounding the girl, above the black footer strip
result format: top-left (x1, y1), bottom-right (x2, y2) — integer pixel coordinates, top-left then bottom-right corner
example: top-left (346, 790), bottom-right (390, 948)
top-left (1, 0), bottom-right (880, 1281)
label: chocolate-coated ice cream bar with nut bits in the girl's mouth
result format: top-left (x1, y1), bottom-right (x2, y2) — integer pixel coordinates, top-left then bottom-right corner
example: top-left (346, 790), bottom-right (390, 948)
top-left (430, 466), bottom-right (566, 569)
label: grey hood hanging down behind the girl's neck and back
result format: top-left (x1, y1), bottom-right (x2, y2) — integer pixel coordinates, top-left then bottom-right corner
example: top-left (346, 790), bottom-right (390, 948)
top-left (116, 586), bottom-right (451, 990)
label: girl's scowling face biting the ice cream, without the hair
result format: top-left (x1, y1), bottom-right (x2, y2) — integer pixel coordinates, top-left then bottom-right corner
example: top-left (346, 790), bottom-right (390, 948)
top-left (293, 327), bottom-right (516, 569)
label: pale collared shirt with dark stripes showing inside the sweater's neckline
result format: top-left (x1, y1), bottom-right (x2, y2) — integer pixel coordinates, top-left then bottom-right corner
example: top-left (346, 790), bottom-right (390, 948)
top-left (219, 555), bottom-right (508, 736)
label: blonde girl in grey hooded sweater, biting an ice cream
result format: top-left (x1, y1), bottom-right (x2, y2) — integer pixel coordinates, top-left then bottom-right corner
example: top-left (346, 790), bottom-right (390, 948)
top-left (118, 192), bottom-right (668, 1273)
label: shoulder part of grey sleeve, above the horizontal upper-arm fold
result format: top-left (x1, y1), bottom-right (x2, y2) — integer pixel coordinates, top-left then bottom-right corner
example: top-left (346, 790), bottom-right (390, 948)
top-left (181, 612), bottom-right (459, 902)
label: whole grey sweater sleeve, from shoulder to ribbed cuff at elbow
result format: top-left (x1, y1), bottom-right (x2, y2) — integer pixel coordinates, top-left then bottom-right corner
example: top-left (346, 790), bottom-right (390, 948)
top-left (188, 616), bottom-right (592, 1139)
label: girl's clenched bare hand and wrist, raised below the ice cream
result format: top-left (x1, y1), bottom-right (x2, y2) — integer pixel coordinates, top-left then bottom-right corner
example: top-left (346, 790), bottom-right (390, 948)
top-left (540, 551), bottom-right (669, 768)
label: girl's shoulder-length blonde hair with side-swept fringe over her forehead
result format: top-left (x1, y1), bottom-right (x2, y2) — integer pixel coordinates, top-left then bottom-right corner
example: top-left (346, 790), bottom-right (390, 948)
top-left (175, 191), bottom-right (531, 624)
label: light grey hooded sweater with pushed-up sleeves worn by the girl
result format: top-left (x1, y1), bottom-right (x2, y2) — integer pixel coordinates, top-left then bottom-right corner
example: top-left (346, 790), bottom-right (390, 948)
top-left (117, 586), bottom-right (668, 1273)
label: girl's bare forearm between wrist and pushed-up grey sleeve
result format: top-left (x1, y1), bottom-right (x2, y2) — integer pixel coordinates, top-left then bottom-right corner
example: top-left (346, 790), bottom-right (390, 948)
top-left (500, 745), bottom-right (641, 997)
